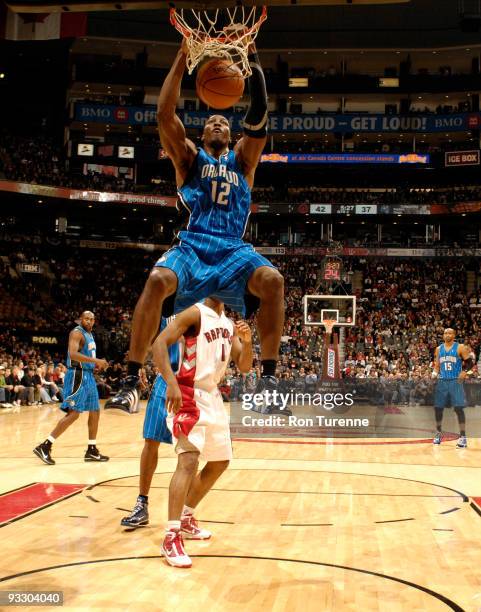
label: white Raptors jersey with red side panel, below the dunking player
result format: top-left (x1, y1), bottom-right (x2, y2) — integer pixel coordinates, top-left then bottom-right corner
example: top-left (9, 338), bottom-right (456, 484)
top-left (177, 304), bottom-right (234, 391)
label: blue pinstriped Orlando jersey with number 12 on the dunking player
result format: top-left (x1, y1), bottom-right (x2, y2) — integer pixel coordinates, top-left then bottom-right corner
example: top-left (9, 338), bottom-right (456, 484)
top-left (178, 148), bottom-right (251, 238)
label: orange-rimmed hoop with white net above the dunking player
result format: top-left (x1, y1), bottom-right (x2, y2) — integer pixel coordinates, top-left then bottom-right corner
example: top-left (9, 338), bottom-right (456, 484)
top-left (170, 6), bottom-right (267, 79)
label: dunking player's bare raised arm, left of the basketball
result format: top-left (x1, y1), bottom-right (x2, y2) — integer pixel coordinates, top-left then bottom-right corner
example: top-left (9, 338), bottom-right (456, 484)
top-left (157, 40), bottom-right (197, 185)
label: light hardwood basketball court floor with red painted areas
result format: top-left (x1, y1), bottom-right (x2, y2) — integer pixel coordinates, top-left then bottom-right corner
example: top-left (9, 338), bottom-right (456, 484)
top-left (0, 407), bottom-right (481, 612)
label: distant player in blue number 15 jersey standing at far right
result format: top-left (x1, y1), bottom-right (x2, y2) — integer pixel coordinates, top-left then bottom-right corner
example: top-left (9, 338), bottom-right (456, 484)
top-left (433, 327), bottom-right (474, 448)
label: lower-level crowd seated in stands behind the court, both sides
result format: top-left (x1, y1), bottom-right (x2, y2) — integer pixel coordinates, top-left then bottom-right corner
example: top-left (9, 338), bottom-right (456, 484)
top-left (0, 227), bottom-right (481, 405)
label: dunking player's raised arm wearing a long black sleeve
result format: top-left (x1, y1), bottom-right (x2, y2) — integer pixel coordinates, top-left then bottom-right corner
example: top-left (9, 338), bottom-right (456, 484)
top-left (234, 43), bottom-right (267, 188)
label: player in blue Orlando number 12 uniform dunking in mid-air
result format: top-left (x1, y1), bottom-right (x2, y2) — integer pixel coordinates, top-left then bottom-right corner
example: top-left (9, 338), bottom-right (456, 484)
top-left (108, 38), bottom-right (284, 412)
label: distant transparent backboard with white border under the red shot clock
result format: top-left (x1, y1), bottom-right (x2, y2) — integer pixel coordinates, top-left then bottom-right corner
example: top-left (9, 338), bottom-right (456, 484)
top-left (303, 295), bottom-right (356, 327)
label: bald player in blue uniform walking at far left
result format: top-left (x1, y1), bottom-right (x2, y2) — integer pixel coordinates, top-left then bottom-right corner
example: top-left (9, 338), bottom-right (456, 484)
top-left (33, 310), bottom-right (109, 465)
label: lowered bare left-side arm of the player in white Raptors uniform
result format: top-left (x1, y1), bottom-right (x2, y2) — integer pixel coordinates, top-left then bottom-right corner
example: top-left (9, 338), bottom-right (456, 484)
top-left (152, 306), bottom-right (200, 413)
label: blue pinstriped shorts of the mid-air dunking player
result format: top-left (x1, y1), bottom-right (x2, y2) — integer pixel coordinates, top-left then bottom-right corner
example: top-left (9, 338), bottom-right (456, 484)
top-left (155, 231), bottom-right (275, 316)
